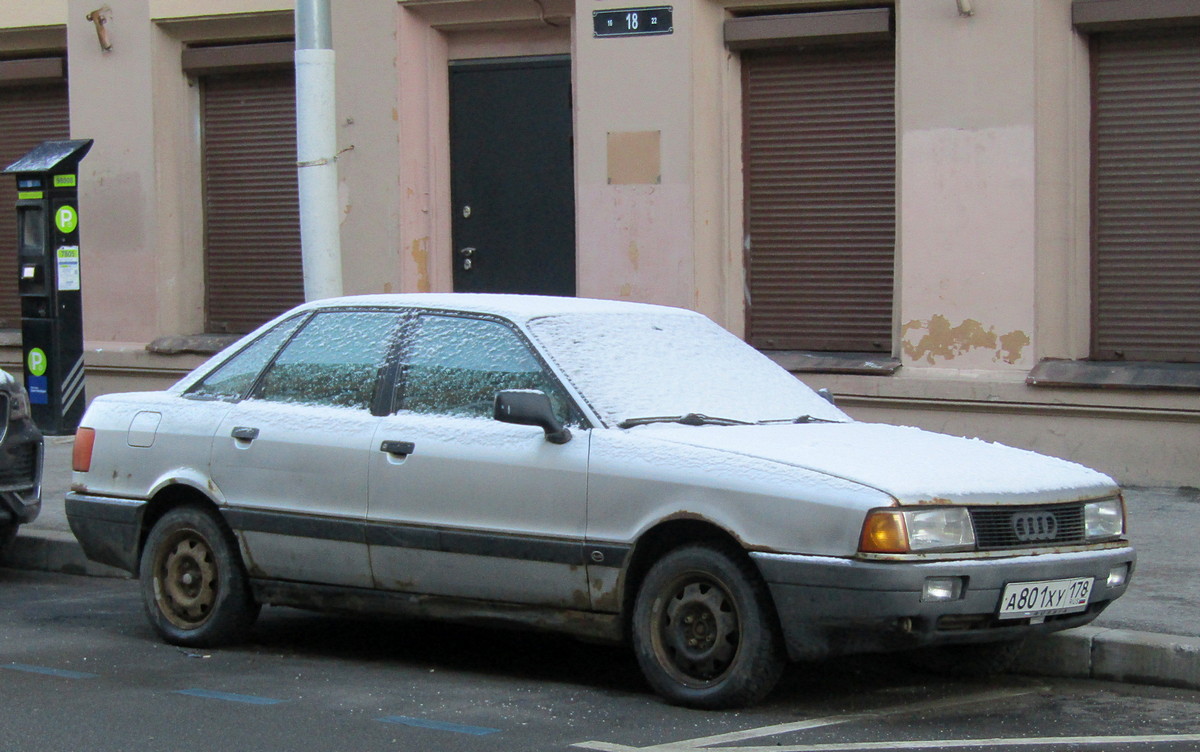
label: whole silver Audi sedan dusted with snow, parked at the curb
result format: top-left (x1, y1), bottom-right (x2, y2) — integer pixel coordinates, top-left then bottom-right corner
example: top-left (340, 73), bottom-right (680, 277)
top-left (67, 294), bottom-right (1134, 708)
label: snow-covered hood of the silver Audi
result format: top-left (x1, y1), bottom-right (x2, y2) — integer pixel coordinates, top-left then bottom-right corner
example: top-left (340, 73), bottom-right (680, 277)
top-left (631, 422), bottom-right (1117, 505)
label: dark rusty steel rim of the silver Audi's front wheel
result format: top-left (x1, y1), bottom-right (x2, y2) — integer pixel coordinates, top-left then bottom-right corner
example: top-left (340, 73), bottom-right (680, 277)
top-left (652, 573), bottom-right (742, 687)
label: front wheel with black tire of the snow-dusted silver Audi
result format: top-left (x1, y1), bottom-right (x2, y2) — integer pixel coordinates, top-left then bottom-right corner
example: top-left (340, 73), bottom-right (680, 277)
top-left (632, 546), bottom-right (786, 709)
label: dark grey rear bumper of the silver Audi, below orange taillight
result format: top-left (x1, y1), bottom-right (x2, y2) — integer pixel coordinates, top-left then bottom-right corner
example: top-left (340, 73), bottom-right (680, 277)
top-left (66, 492), bottom-right (146, 574)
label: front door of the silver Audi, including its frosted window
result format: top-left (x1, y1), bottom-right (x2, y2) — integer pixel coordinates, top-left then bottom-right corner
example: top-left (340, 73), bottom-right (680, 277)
top-left (367, 314), bottom-right (590, 609)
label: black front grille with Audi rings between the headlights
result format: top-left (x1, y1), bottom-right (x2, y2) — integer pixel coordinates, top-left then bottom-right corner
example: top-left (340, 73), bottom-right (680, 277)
top-left (970, 503), bottom-right (1085, 551)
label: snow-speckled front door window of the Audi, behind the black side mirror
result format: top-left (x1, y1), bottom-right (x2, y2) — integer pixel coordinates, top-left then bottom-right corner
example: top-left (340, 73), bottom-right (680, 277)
top-left (392, 315), bottom-right (580, 423)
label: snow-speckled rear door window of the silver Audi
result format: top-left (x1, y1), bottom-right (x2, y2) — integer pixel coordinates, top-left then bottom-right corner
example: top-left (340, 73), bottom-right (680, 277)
top-left (251, 311), bottom-right (400, 409)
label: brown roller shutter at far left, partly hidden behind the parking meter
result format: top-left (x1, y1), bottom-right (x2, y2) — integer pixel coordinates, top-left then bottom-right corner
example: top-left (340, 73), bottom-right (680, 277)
top-left (0, 83), bottom-right (69, 329)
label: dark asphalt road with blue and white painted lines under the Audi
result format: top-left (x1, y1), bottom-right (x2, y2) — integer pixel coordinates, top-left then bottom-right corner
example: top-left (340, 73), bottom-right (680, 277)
top-left (7, 570), bottom-right (1200, 752)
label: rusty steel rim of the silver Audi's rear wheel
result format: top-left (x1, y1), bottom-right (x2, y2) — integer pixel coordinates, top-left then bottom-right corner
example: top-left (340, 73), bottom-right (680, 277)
top-left (154, 530), bottom-right (217, 630)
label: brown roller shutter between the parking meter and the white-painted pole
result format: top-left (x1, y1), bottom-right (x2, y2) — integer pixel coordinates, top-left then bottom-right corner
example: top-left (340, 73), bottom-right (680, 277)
top-left (202, 71), bottom-right (304, 332)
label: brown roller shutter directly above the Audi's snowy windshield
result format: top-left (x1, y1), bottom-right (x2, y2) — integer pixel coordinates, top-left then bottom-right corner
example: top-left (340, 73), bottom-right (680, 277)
top-left (743, 42), bottom-right (896, 353)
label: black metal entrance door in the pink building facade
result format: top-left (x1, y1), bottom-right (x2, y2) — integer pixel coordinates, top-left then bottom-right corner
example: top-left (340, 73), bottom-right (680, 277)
top-left (450, 56), bottom-right (575, 295)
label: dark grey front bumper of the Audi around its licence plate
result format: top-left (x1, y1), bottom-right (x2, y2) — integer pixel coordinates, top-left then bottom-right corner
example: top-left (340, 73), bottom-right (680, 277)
top-left (751, 546), bottom-right (1136, 661)
